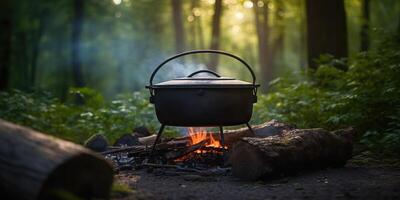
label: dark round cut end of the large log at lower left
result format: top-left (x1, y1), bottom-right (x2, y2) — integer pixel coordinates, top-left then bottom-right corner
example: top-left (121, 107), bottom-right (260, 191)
top-left (37, 153), bottom-right (113, 199)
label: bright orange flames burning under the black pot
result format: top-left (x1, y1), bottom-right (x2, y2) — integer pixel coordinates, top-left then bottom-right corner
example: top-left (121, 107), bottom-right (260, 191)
top-left (188, 127), bottom-right (222, 147)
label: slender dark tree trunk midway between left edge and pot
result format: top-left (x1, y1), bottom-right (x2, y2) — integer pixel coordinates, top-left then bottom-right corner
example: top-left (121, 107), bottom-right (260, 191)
top-left (71, 0), bottom-right (85, 87)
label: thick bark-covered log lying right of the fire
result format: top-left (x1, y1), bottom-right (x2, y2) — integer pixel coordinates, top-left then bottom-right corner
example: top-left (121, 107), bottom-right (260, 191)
top-left (229, 129), bottom-right (354, 180)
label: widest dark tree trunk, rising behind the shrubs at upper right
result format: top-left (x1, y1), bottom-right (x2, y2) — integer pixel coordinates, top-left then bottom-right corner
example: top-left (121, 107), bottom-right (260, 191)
top-left (306, 0), bottom-right (347, 69)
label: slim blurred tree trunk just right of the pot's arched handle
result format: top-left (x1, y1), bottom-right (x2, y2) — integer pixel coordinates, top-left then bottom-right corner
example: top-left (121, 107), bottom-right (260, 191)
top-left (253, 0), bottom-right (273, 91)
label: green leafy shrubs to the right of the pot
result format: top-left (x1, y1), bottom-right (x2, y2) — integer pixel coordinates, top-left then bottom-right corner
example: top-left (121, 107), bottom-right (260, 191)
top-left (254, 34), bottom-right (400, 153)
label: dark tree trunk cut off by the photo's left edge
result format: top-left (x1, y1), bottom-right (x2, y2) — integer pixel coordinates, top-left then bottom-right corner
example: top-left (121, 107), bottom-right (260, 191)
top-left (0, 1), bottom-right (12, 91)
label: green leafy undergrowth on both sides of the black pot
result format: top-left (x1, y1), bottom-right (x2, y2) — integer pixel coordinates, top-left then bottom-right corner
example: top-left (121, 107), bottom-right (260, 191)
top-left (0, 36), bottom-right (400, 155)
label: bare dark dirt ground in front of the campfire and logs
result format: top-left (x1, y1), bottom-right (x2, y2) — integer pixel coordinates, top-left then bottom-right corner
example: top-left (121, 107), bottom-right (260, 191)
top-left (113, 155), bottom-right (400, 200)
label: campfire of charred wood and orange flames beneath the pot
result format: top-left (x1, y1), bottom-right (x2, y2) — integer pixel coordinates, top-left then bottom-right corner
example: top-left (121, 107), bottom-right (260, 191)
top-left (101, 127), bottom-right (228, 173)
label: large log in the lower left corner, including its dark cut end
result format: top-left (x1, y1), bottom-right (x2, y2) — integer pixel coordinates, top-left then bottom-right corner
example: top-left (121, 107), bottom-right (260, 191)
top-left (0, 120), bottom-right (113, 199)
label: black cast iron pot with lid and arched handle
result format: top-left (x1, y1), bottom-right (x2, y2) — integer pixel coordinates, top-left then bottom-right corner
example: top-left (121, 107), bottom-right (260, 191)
top-left (146, 50), bottom-right (259, 127)
